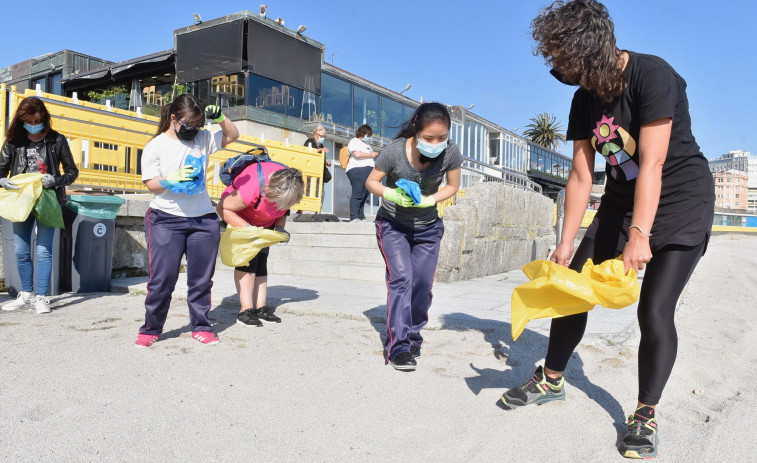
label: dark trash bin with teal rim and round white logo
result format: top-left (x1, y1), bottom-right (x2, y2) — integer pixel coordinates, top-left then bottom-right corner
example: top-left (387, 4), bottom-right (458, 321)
top-left (60, 195), bottom-right (125, 293)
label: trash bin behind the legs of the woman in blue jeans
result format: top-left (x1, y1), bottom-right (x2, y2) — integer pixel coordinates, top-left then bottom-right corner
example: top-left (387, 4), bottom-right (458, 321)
top-left (0, 218), bottom-right (63, 297)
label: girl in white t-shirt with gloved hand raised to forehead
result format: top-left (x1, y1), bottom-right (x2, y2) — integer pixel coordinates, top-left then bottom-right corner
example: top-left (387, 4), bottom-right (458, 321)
top-left (135, 94), bottom-right (239, 347)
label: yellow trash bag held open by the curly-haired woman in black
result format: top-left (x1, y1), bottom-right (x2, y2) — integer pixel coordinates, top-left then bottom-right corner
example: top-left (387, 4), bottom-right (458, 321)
top-left (510, 256), bottom-right (640, 341)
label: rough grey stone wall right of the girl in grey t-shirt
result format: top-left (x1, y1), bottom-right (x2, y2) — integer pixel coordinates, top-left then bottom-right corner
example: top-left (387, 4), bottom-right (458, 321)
top-left (436, 182), bottom-right (555, 282)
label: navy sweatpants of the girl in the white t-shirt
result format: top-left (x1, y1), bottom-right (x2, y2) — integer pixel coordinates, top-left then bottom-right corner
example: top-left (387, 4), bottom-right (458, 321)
top-left (139, 209), bottom-right (221, 334)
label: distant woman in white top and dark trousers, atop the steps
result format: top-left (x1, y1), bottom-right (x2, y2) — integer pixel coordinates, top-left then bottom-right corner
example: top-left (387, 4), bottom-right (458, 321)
top-left (346, 124), bottom-right (378, 222)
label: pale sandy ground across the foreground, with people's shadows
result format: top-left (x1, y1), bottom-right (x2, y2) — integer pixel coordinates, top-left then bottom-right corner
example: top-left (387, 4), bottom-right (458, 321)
top-left (0, 237), bottom-right (757, 462)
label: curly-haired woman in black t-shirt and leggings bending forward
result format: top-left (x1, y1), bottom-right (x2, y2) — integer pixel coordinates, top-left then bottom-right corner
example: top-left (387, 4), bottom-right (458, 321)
top-left (499, 0), bottom-right (714, 458)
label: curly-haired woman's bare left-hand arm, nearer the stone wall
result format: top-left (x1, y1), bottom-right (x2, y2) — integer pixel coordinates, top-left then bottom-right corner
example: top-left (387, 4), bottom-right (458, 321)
top-left (550, 140), bottom-right (594, 267)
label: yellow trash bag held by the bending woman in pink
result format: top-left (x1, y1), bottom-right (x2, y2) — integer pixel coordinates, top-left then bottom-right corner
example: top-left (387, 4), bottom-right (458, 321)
top-left (220, 226), bottom-right (288, 267)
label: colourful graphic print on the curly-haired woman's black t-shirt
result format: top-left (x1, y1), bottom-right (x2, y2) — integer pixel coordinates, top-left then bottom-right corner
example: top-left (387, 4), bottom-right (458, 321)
top-left (591, 114), bottom-right (639, 181)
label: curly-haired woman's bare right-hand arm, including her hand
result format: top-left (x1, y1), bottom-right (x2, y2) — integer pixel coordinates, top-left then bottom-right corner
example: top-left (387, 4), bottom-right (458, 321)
top-left (623, 118), bottom-right (673, 271)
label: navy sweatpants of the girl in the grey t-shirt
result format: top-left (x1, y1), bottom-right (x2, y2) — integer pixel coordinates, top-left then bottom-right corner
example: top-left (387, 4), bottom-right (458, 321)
top-left (376, 217), bottom-right (444, 362)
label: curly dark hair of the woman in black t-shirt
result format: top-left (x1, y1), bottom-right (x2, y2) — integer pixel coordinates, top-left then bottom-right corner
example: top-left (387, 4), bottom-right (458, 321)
top-left (531, 0), bottom-right (628, 103)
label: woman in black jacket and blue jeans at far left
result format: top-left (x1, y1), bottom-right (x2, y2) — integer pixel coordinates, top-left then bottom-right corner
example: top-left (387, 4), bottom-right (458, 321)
top-left (0, 97), bottom-right (79, 313)
